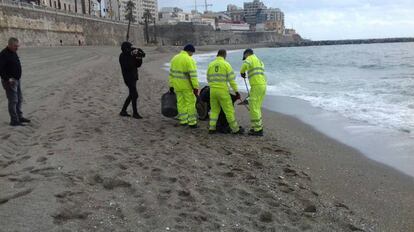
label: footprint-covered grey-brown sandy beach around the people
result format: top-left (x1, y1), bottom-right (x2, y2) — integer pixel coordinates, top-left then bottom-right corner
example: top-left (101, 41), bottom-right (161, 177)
top-left (0, 47), bottom-right (414, 232)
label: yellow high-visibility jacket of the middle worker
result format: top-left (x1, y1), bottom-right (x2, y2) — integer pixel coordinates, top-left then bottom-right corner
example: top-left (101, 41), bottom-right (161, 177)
top-left (207, 57), bottom-right (238, 92)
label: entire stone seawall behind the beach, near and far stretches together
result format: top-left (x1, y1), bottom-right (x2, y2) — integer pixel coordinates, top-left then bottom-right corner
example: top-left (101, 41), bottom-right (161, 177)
top-left (0, 2), bottom-right (298, 47)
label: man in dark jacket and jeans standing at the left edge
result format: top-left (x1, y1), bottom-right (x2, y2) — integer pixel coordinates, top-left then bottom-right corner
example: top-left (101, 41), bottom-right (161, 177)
top-left (0, 38), bottom-right (30, 126)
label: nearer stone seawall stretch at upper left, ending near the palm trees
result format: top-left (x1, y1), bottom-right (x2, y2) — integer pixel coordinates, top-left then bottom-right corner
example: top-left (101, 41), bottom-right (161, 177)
top-left (0, 5), bottom-right (144, 47)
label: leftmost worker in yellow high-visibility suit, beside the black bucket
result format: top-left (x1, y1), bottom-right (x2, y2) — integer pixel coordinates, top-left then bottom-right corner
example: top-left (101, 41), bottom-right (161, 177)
top-left (169, 44), bottom-right (199, 128)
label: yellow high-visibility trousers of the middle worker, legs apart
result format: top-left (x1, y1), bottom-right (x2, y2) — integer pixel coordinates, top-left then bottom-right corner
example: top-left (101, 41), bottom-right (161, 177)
top-left (210, 88), bottom-right (239, 133)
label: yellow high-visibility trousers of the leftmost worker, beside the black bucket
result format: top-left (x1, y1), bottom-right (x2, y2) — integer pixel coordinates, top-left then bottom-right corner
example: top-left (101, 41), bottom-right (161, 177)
top-left (175, 90), bottom-right (197, 126)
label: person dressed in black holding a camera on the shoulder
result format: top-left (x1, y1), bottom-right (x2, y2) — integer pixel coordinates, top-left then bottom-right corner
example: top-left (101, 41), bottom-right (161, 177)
top-left (119, 42), bottom-right (145, 119)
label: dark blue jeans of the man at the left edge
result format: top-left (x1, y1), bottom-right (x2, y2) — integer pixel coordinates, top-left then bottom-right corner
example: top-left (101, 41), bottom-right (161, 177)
top-left (1, 80), bottom-right (23, 122)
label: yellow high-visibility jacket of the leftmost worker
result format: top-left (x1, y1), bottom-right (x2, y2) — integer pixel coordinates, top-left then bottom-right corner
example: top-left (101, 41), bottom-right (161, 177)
top-left (169, 51), bottom-right (199, 91)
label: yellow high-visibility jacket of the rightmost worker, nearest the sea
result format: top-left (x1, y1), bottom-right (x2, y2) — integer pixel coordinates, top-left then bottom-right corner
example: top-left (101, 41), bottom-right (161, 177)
top-left (240, 55), bottom-right (266, 86)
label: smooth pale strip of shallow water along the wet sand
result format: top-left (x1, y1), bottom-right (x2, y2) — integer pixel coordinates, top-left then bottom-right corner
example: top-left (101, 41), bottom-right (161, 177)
top-left (264, 95), bottom-right (414, 179)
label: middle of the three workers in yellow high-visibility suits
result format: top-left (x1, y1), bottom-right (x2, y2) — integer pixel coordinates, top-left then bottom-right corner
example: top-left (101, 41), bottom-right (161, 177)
top-left (207, 49), bottom-right (244, 134)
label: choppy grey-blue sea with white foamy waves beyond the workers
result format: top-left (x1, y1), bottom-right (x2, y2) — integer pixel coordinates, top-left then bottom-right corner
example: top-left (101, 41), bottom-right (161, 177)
top-left (196, 43), bottom-right (414, 136)
